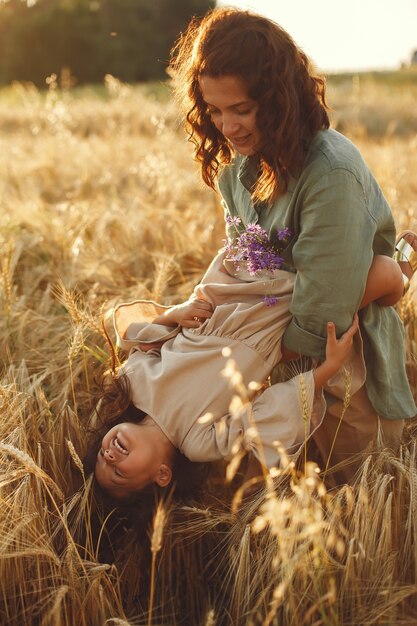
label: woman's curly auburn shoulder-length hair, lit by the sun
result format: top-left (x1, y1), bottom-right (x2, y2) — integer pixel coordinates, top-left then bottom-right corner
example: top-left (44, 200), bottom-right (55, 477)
top-left (169, 8), bottom-right (329, 203)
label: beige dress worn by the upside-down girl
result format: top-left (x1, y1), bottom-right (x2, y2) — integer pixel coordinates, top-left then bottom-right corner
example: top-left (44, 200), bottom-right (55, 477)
top-left (113, 253), bottom-right (364, 467)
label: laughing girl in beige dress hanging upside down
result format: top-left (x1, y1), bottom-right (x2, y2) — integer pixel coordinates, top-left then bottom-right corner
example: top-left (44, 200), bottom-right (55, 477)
top-left (95, 244), bottom-right (412, 499)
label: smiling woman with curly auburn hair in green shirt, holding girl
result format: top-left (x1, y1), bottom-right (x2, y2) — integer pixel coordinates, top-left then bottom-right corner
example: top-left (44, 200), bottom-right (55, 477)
top-left (170, 8), bottom-right (417, 481)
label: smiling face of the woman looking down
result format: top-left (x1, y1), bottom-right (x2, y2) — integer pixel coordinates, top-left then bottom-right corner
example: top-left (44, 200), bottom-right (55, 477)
top-left (199, 75), bottom-right (260, 156)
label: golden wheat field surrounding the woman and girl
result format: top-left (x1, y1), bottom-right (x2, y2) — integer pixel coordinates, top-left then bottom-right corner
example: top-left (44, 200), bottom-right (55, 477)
top-left (0, 74), bottom-right (417, 626)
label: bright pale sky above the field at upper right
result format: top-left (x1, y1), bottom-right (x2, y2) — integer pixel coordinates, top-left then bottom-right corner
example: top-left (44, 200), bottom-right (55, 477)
top-left (218, 0), bottom-right (417, 72)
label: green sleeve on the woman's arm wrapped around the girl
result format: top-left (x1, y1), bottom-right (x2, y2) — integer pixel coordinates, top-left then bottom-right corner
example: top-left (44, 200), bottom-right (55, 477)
top-left (283, 168), bottom-right (376, 358)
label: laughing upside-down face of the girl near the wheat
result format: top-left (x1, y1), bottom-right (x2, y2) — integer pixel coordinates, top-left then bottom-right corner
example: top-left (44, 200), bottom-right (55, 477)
top-left (94, 420), bottom-right (172, 499)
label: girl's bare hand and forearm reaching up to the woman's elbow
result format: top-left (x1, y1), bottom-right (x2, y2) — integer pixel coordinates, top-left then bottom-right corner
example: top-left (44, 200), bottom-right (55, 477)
top-left (313, 313), bottom-right (359, 391)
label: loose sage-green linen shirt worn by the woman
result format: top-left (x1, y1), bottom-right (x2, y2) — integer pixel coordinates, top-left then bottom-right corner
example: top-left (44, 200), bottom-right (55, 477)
top-left (219, 129), bottom-right (417, 419)
